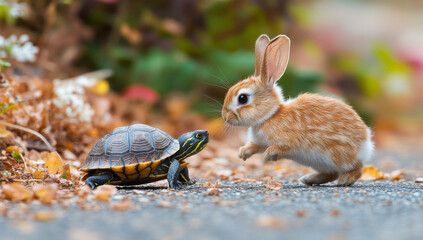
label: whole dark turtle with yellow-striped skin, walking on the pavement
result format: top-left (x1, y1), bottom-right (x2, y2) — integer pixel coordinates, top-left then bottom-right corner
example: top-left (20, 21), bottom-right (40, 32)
top-left (79, 124), bottom-right (209, 190)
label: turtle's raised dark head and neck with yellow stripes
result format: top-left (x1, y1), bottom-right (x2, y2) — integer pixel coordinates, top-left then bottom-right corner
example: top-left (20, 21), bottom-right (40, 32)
top-left (175, 130), bottom-right (209, 160)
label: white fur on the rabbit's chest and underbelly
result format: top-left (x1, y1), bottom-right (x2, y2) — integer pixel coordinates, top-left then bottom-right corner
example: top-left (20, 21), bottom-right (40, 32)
top-left (248, 127), bottom-right (354, 173)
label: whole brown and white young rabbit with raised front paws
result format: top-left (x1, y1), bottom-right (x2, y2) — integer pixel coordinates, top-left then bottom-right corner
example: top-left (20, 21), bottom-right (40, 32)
top-left (222, 35), bottom-right (374, 186)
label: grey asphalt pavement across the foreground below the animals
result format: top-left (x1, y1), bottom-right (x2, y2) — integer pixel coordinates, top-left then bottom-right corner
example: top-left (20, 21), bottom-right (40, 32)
top-left (0, 179), bottom-right (423, 240)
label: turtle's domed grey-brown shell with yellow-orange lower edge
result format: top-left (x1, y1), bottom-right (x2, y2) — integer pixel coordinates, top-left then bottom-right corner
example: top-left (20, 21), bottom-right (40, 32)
top-left (79, 124), bottom-right (183, 184)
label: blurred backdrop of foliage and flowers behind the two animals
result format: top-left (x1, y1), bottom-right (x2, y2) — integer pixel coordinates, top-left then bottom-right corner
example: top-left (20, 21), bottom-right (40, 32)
top-left (0, 0), bottom-right (423, 159)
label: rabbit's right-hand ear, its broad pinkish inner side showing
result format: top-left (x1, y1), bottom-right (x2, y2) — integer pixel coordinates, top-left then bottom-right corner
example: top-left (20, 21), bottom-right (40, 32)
top-left (260, 35), bottom-right (291, 88)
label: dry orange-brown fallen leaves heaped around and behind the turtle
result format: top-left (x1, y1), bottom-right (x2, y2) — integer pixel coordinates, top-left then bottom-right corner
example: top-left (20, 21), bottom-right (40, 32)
top-left (0, 73), bottom-right (420, 223)
